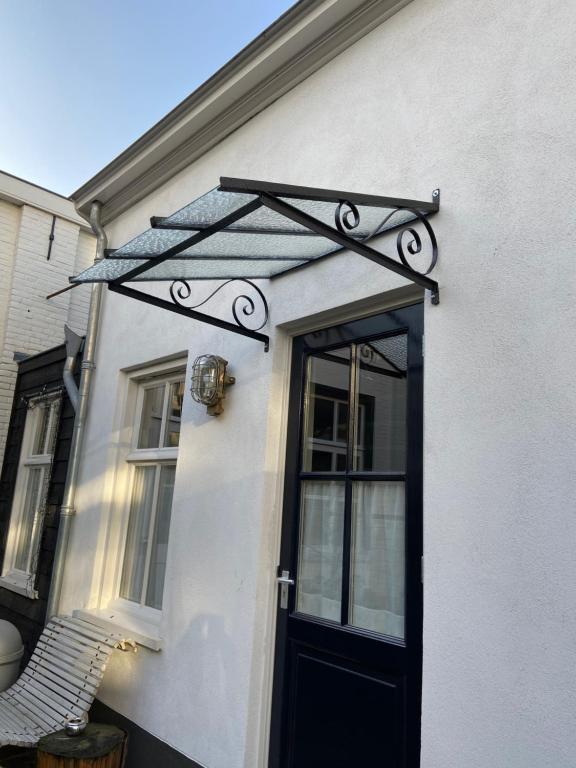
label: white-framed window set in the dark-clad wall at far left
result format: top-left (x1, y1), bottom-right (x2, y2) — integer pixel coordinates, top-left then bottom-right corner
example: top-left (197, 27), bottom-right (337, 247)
top-left (0, 392), bottom-right (61, 598)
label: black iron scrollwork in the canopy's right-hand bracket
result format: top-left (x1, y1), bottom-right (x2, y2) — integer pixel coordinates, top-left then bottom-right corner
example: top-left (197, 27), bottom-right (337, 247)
top-left (334, 190), bottom-right (439, 275)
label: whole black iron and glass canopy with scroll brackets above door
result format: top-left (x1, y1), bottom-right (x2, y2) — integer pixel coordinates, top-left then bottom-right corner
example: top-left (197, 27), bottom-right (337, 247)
top-left (71, 177), bottom-right (440, 349)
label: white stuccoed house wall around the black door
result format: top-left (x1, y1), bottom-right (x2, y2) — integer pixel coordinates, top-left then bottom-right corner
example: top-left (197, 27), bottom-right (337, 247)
top-left (64, 0), bottom-right (576, 768)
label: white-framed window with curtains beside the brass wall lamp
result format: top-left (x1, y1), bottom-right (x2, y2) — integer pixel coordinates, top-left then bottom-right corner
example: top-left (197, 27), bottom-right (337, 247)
top-left (116, 372), bottom-right (184, 614)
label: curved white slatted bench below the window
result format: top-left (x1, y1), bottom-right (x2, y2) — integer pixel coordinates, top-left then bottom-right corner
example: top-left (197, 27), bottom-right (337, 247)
top-left (0, 616), bottom-right (135, 747)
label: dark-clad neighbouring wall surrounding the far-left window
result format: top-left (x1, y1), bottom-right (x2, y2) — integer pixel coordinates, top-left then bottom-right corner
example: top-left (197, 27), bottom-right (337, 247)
top-left (0, 345), bottom-right (80, 662)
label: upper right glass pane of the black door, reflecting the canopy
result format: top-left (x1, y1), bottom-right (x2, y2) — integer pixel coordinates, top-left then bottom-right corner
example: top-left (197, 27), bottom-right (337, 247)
top-left (354, 334), bottom-right (407, 472)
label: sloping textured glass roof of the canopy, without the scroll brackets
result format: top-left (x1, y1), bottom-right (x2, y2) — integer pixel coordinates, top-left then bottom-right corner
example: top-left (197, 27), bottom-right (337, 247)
top-left (71, 178), bottom-right (438, 284)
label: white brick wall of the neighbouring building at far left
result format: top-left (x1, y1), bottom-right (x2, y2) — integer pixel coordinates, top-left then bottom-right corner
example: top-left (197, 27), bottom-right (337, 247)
top-left (0, 201), bottom-right (95, 463)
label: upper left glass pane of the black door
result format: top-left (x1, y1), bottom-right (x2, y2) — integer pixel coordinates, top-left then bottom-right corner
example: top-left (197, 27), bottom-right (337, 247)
top-left (302, 347), bottom-right (350, 472)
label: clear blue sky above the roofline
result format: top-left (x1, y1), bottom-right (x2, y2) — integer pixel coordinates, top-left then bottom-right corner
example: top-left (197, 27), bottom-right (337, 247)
top-left (0, 0), bottom-right (293, 195)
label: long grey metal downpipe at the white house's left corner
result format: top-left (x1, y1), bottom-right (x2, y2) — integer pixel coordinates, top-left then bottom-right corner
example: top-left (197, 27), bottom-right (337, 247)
top-left (46, 201), bottom-right (107, 622)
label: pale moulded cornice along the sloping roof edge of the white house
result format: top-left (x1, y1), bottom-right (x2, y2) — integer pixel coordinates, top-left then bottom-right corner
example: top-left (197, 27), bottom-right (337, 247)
top-left (70, 0), bottom-right (411, 223)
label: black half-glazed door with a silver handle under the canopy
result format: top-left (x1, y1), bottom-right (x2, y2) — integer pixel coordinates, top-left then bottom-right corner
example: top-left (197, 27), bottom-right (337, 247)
top-left (270, 304), bottom-right (423, 768)
